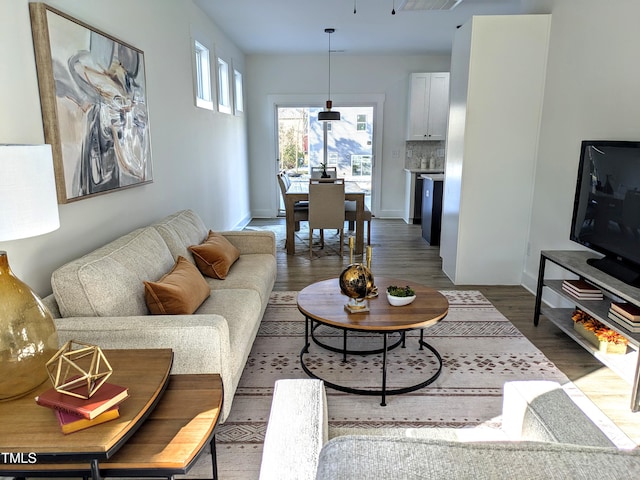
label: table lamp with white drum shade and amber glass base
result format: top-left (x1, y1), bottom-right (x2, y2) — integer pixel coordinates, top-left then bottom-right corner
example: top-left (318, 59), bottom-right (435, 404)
top-left (0, 145), bottom-right (60, 401)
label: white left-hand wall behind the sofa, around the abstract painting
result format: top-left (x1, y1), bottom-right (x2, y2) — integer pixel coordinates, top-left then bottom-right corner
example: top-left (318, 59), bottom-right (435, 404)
top-left (0, 0), bottom-right (250, 295)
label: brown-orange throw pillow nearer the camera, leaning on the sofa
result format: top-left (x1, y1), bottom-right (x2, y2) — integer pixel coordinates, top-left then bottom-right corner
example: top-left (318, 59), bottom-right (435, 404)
top-left (144, 257), bottom-right (211, 315)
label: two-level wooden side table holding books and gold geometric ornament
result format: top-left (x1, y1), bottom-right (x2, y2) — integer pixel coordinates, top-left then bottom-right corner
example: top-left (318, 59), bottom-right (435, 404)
top-left (0, 349), bottom-right (222, 479)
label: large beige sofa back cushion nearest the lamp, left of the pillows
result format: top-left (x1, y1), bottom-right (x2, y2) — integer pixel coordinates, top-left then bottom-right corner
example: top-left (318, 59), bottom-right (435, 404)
top-left (51, 227), bottom-right (175, 317)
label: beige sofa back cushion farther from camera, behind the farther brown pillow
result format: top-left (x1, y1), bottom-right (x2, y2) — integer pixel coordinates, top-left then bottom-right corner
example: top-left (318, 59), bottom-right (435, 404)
top-left (153, 210), bottom-right (209, 264)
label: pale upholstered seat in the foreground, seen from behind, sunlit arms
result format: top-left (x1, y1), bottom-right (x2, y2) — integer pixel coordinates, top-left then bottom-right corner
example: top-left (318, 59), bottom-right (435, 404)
top-left (260, 379), bottom-right (640, 480)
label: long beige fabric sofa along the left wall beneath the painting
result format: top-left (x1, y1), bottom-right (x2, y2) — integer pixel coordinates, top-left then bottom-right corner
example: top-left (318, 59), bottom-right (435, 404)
top-left (43, 210), bottom-right (276, 421)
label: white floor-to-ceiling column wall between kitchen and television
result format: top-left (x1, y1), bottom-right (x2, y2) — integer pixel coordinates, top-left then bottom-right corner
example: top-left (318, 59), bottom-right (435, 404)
top-left (440, 15), bottom-right (550, 285)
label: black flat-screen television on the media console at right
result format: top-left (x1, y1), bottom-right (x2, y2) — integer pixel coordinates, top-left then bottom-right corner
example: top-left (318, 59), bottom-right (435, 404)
top-left (570, 140), bottom-right (640, 286)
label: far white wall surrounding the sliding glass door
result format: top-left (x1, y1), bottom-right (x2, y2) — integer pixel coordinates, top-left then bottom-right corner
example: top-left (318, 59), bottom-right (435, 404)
top-left (246, 54), bottom-right (450, 218)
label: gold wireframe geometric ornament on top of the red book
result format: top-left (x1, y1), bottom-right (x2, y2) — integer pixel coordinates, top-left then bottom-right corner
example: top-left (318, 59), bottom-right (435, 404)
top-left (46, 340), bottom-right (113, 399)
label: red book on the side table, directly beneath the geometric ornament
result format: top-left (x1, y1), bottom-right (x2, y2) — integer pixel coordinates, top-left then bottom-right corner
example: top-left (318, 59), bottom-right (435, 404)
top-left (36, 382), bottom-right (129, 420)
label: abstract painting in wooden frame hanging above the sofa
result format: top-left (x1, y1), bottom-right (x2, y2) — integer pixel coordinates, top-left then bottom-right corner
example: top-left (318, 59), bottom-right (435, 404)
top-left (29, 3), bottom-right (153, 203)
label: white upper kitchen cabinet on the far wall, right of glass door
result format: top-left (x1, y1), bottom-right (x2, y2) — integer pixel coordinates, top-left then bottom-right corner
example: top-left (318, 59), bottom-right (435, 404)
top-left (407, 72), bottom-right (449, 140)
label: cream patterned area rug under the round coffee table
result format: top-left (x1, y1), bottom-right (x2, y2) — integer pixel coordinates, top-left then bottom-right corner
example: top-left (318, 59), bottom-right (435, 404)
top-left (193, 291), bottom-right (568, 479)
